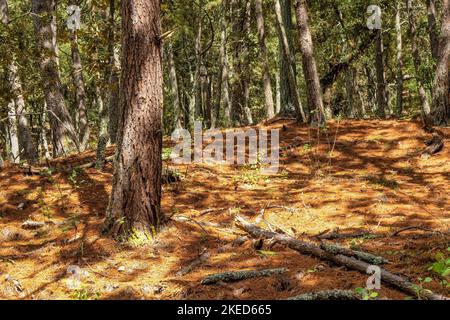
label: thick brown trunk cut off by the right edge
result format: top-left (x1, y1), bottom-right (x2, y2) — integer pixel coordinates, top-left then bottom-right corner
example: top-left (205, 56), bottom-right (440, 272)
top-left (431, 0), bottom-right (450, 125)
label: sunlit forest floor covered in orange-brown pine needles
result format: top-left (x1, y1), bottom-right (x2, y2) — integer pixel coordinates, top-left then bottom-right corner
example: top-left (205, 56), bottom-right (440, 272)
top-left (0, 120), bottom-right (450, 299)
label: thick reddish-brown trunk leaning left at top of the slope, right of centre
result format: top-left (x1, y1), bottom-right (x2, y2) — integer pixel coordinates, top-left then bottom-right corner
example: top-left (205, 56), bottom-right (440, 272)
top-left (296, 0), bottom-right (326, 124)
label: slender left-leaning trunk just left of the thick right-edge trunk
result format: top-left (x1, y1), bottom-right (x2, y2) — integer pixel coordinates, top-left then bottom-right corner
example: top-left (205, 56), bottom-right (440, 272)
top-left (406, 0), bottom-right (430, 116)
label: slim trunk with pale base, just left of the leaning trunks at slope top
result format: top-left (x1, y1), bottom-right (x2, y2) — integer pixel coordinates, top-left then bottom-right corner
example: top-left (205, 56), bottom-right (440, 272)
top-left (255, 0), bottom-right (275, 119)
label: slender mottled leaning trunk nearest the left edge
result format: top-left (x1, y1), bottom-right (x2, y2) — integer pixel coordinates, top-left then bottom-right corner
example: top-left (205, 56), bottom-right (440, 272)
top-left (9, 61), bottom-right (38, 164)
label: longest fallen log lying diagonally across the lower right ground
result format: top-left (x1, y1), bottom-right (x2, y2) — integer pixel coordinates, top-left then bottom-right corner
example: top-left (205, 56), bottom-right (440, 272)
top-left (235, 215), bottom-right (449, 300)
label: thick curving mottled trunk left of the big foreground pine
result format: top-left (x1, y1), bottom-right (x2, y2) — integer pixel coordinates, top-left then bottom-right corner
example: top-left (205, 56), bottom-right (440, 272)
top-left (32, 0), bottom-right (79, 156)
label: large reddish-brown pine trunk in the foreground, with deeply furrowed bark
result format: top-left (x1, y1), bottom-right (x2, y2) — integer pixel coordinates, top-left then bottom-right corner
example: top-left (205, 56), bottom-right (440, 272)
top-left (106, 0), bottom-right (164, 237)
